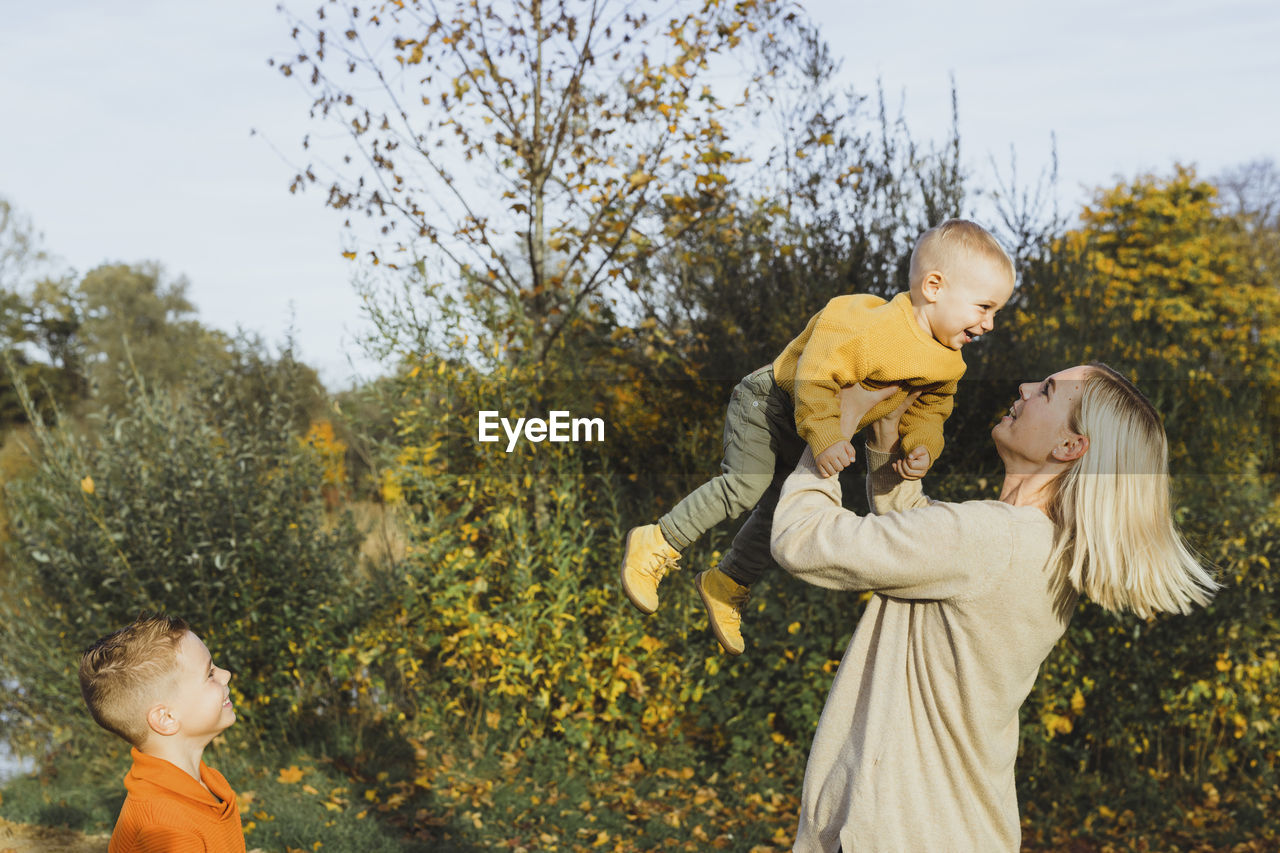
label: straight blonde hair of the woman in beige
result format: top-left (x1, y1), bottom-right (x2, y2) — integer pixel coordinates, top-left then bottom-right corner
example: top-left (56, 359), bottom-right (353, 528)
top-left (1048, 362), bottom-right (1219, 619)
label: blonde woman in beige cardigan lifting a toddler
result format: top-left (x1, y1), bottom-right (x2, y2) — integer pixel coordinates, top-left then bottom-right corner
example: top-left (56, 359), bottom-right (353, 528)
top-left (772, 364), bottom-right (1217, 853)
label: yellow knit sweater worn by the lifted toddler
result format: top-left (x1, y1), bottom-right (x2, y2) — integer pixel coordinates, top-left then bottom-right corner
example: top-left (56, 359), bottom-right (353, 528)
top-left (773, 292), bottom-right (965, 464)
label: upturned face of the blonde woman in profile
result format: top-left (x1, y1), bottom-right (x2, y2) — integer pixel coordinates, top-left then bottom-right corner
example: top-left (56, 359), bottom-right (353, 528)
top-left (991, 365), bottom-right (1089, 473)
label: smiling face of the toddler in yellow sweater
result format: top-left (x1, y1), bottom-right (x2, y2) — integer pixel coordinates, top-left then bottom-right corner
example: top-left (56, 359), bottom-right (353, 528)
top-left (925, 257), bottom-right (1014, 350)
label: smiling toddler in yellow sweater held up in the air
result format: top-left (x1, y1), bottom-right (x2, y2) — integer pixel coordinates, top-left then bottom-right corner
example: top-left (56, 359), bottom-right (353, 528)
top-left (621, 219), bottom-right (1015, 654)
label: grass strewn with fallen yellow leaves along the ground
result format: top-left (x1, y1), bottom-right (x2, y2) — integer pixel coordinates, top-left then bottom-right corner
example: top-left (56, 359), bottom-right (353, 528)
top-left (0, 733), bottom-right (1277, 853)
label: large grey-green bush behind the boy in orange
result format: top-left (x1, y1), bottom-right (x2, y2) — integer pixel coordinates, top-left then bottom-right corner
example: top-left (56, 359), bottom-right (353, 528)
top-left (0, 347), bottom-right (371, 751)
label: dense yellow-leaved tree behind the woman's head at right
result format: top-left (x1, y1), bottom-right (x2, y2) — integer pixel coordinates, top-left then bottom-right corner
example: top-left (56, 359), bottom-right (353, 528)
top-left (1009, 167), bottom-right (1280, 440)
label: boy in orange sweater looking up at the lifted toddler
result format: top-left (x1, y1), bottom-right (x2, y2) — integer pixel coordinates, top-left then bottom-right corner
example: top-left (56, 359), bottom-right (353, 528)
top-left (79, 615), bottom-right (244, 853)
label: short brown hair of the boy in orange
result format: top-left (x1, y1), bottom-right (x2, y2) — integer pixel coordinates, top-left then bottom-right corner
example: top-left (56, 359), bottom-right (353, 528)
top-left (79, 613), bottom-right (189, 747)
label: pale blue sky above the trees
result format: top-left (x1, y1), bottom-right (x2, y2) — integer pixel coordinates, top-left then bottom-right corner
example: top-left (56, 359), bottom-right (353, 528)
top-left (0, 0), bottom-right (1280, 391)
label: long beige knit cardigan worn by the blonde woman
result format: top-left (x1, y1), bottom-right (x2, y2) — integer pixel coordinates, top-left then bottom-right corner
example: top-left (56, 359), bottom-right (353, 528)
top-left (773, 451), bottom-right (1074, 853)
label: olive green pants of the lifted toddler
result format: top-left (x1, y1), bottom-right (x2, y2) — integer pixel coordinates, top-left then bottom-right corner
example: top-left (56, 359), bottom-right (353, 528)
top-left (658, 365), bottom-right (805, 587)
